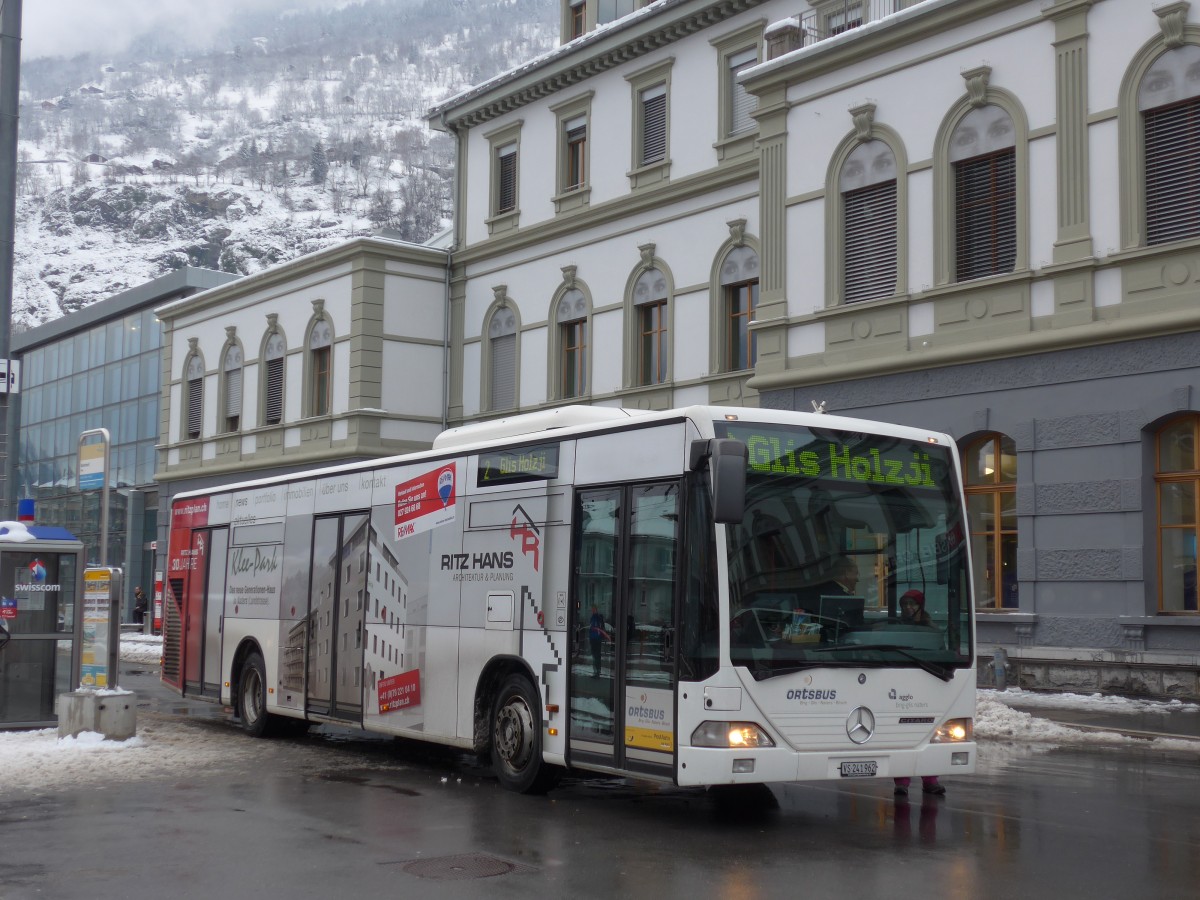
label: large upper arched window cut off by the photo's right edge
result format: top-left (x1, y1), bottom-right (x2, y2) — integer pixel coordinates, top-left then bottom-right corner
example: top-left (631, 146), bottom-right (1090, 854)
top-left (1138, 44), bottom-right (1200, 244)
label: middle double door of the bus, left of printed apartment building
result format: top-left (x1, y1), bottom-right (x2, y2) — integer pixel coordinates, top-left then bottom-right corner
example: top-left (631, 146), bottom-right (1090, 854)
top-left (306, 514), bottom-right (371, 720)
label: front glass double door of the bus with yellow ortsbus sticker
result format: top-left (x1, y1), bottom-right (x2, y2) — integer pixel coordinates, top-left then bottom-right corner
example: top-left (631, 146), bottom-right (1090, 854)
top-left (569, 482), bottom-right (679, 776)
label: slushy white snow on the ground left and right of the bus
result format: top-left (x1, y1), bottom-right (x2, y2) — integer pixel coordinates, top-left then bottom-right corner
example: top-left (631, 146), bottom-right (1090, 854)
top-left (0, 635), bottom-right (1200, 797)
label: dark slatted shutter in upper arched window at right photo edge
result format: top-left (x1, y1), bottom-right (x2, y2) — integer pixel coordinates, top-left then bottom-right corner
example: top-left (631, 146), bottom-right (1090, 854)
top-left (1145, 100), bottom-right (1200, 244)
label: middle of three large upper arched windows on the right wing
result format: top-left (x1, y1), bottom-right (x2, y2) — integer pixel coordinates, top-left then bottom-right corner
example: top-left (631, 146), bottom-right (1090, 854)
top-left (948, 103), bottom-right (1016, 281)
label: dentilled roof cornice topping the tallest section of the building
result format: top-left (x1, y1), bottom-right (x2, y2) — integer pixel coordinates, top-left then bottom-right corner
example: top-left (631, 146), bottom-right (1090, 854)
top-left (425, 0), bottom-right (767, 131)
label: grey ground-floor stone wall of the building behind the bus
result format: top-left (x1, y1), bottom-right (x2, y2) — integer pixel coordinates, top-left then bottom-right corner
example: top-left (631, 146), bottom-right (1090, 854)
top-left (763, 334), bottom-right (1200, 652)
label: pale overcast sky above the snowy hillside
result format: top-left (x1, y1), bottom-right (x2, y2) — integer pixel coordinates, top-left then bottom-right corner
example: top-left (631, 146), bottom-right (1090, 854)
top-left (20, 0), bottom-right (354, 59)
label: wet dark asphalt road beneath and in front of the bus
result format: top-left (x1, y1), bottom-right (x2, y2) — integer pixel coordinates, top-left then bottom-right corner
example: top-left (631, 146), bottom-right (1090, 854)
top-left (0, 667), bottom-right (1200, 900)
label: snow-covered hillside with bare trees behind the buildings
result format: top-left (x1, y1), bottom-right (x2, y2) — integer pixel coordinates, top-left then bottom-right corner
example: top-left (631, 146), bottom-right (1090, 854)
top-left (13, 0), bottom-right (559, 330)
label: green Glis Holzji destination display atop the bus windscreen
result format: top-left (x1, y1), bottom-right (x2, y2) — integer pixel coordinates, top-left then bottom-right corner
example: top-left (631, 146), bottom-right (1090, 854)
top-left (724, 424), bottom-right (949, 487)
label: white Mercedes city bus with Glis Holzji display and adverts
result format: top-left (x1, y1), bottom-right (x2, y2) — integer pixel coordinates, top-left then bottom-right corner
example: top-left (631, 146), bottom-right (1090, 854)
top-left (163, 407), bottom-right (976, 792)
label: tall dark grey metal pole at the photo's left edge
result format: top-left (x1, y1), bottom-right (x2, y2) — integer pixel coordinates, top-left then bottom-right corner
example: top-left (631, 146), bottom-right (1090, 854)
top-left (0, 0), bottom-right (20, 518)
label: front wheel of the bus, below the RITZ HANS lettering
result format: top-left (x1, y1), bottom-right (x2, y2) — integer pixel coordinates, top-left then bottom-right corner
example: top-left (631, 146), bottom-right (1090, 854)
top-left (491, 674), bottom-right (559, 793)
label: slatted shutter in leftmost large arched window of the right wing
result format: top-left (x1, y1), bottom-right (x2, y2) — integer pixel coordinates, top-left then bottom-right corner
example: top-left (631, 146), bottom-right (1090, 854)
top-left (842, 181), bottom-right (896, 304)
